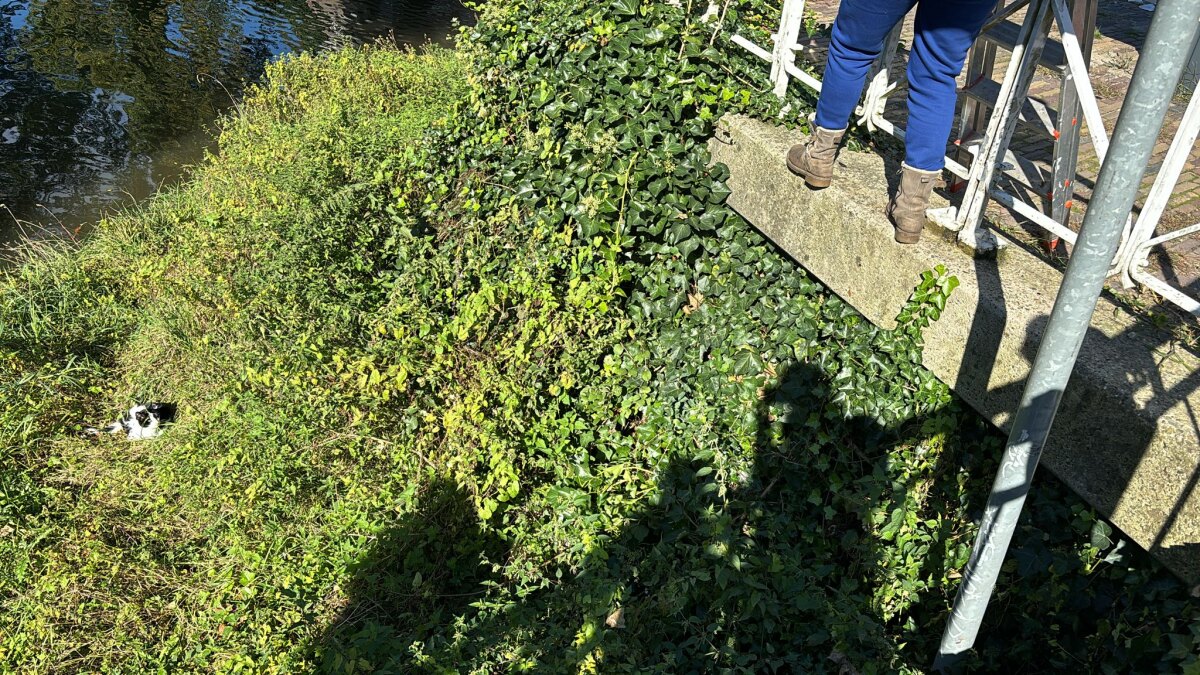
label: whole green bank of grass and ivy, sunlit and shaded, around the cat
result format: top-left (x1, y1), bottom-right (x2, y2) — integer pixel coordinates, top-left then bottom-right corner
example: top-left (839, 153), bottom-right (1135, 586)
top-left (0, 0), bottom-right (1200, 673)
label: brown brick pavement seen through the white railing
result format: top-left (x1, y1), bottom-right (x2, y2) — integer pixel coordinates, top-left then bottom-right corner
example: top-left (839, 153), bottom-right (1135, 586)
top-left (792, 0), bottom-right (1200, 295)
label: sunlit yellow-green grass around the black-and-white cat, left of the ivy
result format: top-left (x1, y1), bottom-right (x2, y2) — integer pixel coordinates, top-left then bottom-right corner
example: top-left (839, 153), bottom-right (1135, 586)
top-left (0, 49), bottom-right (482, 671)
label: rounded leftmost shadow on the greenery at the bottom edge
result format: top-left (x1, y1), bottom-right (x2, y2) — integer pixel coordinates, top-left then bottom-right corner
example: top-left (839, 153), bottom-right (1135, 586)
top-left (313, 478), bottom-right (506, 673)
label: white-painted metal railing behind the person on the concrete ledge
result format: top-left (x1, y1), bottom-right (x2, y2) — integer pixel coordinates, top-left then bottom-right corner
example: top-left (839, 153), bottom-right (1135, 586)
top-left (732, 0), bottom-right (1200, 316)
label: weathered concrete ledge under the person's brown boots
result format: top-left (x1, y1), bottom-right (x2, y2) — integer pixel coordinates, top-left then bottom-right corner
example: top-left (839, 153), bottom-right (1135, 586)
top-left (710, 117), bottom-right (1200, 586)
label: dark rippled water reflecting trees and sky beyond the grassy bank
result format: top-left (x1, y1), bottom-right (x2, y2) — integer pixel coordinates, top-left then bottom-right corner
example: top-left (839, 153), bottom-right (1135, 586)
top-left (0, 0), bottom-right (472, 244)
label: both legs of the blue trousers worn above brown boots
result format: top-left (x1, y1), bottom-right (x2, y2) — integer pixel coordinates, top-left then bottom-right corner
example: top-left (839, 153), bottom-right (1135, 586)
top-left (816, 0), bottom-right (996, 171)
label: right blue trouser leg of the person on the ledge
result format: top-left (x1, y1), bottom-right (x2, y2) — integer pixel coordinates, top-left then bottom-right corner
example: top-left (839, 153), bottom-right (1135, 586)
top-left (905, 0), bottom-right (996, 172)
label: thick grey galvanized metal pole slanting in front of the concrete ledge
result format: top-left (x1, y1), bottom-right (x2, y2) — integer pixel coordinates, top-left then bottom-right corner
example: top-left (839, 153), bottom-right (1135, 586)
top-left (934, 0), bottom-right (1200, 670)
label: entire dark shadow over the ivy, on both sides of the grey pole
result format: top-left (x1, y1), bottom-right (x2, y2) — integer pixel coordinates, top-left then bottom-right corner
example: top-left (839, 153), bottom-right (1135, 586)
top-left (316, 355), bottom-right (1194, 674)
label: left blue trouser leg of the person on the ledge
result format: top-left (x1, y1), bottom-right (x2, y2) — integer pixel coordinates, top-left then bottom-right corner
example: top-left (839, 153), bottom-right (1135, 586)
top-left (816, 0), bottom-right (917, 130)
